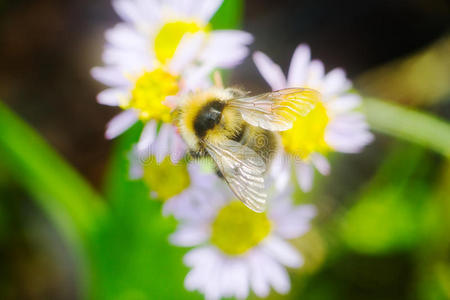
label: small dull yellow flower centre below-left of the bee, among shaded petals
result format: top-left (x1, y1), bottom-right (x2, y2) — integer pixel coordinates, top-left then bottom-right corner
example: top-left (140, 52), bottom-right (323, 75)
top-left (143, 156), bottom-right (191, 201)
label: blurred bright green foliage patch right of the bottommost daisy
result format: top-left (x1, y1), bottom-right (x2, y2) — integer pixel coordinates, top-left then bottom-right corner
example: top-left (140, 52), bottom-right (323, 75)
top-left (342, 146), bottom-right (438, 254)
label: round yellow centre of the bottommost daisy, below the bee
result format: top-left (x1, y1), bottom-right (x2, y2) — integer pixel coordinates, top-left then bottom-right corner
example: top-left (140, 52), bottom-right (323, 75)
top-left (211, 200), bottom-right (271, 255)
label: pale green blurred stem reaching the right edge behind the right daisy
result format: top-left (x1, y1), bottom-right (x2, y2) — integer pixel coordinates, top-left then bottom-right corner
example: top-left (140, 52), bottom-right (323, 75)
top-left (364, 99), bottom-right (450, 157)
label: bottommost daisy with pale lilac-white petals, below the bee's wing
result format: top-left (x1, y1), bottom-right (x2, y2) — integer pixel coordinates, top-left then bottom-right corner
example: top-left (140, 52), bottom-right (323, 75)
top-left (170, 181), bottom-right (315, 299)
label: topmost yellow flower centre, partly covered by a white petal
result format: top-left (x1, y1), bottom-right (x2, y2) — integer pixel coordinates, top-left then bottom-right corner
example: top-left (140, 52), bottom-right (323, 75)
top-left (154, 21), bottom-right (206, 64)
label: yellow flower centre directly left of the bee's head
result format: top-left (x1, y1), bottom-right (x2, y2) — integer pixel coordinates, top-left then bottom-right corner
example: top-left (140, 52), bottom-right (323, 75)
top-left (126, 68), bottom-right (178, 122)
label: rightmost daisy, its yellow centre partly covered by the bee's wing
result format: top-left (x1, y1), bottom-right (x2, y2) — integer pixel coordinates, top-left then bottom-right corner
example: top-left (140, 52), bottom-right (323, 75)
top-left (253, 45), bottom-right (373, 191)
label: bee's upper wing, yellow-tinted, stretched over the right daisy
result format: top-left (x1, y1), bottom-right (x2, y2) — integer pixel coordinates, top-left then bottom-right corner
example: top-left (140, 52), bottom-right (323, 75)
top-left (229, 88), bottom-right (320, 131)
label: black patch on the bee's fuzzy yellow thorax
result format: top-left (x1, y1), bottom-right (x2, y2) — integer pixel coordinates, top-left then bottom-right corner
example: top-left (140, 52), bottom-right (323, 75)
top-left (194, 100), bottom-right (225, 139)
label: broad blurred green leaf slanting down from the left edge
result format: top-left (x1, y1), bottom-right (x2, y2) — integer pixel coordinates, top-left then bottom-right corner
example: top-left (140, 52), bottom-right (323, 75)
top-left (0, 102), bottom-right (104, 296)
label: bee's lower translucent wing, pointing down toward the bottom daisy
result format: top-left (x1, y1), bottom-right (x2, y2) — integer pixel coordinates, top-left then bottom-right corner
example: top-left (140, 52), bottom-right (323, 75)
top-left (206, 140), bottom-right (267, 212)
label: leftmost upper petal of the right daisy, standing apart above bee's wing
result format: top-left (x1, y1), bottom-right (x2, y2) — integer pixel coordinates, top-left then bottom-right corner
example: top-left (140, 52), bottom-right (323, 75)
top-left (253, 52), bottom-right (286, 90)
